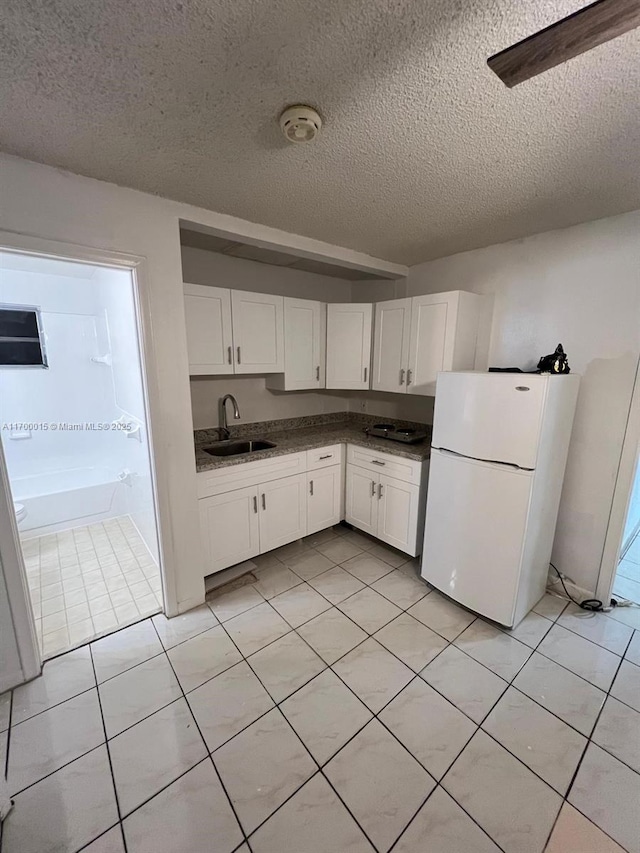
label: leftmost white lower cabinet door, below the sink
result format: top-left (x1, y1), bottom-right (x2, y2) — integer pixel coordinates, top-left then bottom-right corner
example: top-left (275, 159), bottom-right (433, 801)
top-left (198, 486), bottom-right (260, 576)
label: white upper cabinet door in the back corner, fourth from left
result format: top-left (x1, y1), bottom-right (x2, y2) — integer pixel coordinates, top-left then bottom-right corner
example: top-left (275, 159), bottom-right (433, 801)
top-left (327, 303), bottom-right (373, 390)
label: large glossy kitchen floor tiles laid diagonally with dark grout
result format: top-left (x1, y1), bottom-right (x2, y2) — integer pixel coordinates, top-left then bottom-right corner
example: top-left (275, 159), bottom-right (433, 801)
top-left (0, 527), bottom-right (640, 853)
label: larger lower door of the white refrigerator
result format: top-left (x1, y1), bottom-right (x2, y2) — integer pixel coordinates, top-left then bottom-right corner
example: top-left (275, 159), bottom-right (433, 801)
top-left (421, 450), bottom-right (534, 626)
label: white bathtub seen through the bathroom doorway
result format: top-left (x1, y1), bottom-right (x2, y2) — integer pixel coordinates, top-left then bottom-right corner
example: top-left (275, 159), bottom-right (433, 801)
top-left (11, 467), bottom-right (126, 538)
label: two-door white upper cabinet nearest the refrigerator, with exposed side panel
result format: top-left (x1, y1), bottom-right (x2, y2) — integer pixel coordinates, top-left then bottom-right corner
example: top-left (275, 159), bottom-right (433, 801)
top-left (372, 290), bottom-right (482, 396)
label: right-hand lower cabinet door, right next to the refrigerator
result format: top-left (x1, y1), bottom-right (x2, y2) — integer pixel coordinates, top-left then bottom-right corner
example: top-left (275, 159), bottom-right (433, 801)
top-left (377, 474), bottom-right (422, 556)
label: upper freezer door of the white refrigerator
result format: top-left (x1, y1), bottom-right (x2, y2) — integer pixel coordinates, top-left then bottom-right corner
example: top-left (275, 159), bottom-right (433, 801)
top-left (431, 373), bottom-right (549, 468)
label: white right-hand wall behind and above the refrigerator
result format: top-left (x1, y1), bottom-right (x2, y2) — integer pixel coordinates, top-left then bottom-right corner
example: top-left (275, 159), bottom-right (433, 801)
top-left (407, 212), bottom-right (640, 592)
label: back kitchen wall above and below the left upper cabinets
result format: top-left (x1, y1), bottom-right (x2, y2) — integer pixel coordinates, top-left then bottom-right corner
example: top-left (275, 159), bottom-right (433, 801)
top-left (182, 247), bottom-right (351, 429)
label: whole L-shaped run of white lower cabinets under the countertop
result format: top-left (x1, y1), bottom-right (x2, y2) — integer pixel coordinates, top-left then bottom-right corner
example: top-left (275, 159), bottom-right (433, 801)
top-left (197, 444), bottom-right (427, 576)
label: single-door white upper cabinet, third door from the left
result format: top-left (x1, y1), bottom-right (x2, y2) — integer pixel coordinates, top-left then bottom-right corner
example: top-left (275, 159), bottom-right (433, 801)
top-left (266, 296), bottom-right (327, 391)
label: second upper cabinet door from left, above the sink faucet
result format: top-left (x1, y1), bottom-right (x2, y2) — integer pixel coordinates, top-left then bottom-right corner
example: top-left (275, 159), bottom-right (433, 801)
top-left (231, 290), bottom-right (284, 373)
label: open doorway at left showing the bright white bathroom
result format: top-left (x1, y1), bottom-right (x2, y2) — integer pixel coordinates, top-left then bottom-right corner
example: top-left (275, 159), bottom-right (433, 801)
top-left (0, 250), bottom-right (163, 658)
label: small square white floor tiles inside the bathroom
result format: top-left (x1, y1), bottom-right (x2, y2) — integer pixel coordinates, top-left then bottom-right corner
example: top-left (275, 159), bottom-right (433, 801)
top-left (22, 516), bottom-right (162, 658)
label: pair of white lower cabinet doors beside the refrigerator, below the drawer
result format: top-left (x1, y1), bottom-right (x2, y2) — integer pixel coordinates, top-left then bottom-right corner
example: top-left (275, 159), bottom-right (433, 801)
top-left (345, 465), bottom-right (426, 557)
